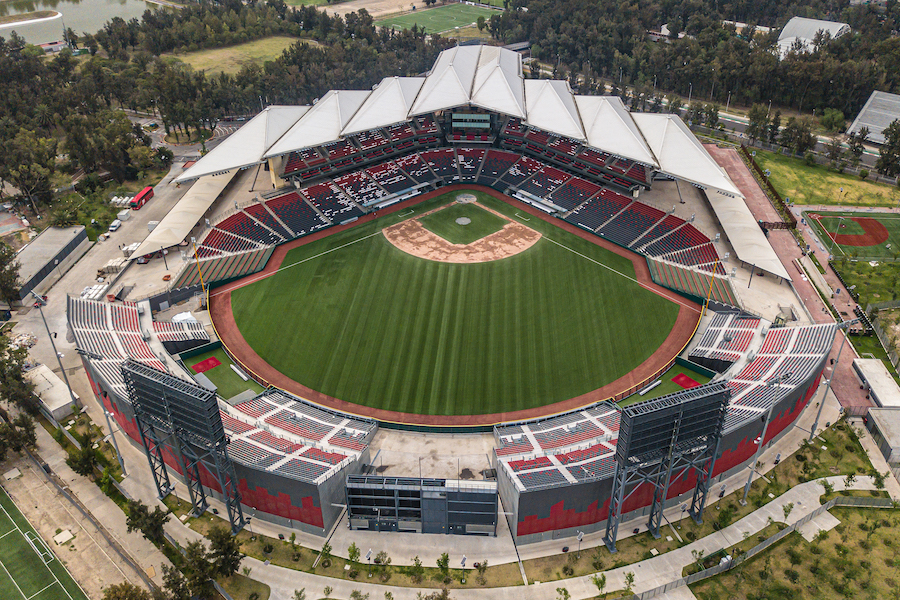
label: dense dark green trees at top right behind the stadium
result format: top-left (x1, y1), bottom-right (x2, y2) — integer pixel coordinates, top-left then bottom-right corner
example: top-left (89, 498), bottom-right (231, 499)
top-left (488, 0), bottom-right (900, 120)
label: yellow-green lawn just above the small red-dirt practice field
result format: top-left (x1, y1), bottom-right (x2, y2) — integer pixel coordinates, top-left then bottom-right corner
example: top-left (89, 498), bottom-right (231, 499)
top-left (756, 150), bottom-right (900, 206)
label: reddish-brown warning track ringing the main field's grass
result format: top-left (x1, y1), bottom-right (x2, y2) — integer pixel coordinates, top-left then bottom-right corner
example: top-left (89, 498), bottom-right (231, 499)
top-left (209, 184), bottom-right (700, 427)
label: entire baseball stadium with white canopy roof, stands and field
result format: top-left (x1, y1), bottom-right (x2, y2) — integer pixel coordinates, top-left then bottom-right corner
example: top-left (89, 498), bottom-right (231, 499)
top-left (68, 46), bottom-right (835, 543)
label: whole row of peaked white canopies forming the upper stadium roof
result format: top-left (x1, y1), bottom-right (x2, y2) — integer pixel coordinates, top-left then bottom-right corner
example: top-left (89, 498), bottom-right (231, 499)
top-left (175, 46), bottom-right (741, 196)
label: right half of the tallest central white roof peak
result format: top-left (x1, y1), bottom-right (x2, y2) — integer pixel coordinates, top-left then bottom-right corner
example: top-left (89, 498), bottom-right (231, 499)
top-left (470, 46), bottom-right (525, 119)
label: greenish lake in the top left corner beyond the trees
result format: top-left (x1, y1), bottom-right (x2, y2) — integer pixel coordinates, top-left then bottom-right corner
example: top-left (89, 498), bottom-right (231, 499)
top-left (0, 0), bottom-right (158, 44)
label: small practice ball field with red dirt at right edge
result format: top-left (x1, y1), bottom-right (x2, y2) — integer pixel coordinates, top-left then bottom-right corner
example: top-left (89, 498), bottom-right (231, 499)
top-left (803, 211), bottom-right (900, 261)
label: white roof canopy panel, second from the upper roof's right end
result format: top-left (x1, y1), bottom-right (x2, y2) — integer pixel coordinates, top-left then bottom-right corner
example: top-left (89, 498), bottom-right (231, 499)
top-left (575, 96), bottom-right (659, 167)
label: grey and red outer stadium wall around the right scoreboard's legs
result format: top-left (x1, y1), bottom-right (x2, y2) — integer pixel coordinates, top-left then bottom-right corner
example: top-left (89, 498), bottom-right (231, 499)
top-left (497, 356), bottom-right (828, 544)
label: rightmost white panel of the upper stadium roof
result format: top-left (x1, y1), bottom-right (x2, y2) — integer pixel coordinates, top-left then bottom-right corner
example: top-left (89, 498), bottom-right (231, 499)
top-left (631, 113), bottom-right (744, 198)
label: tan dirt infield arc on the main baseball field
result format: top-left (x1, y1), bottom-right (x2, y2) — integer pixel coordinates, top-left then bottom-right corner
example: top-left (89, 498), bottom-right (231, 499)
top-left (382, 202), bottom-right (541, 264)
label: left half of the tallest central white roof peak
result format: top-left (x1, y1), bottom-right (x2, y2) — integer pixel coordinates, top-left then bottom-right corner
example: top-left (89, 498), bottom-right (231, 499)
top-left (409, 46), bottom-right (482, 116)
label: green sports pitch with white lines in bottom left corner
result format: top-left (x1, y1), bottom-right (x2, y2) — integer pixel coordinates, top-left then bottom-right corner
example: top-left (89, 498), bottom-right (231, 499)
top-left (0, 489), bottom-right (88, 600)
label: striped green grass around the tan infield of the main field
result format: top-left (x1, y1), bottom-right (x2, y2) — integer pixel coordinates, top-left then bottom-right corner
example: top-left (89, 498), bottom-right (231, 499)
top-left (232, 192), bottom-right (678, 415)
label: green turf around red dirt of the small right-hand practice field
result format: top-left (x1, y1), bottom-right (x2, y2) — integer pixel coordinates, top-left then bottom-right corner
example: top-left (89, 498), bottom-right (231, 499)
top-left (804, 211), bottom-right (900, 261)
